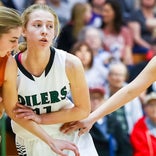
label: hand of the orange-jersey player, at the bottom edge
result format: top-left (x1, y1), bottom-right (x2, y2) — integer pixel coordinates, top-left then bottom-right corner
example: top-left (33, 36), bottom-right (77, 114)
top-left (48, 139), bottom-right (80, 156)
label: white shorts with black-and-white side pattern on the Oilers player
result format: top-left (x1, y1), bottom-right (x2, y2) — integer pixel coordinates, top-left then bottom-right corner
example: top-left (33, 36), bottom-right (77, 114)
top-left (16, 133), bottom-right (98, 156)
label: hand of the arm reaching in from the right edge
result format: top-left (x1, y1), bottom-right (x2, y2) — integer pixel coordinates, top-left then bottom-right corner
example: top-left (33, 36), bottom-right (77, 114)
top-left (60, 118), bottom-right (93, 136)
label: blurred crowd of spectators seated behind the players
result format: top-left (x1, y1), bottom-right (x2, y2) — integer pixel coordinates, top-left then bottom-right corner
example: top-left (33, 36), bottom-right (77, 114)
top-left (1, 0), bottom-right (156, 156)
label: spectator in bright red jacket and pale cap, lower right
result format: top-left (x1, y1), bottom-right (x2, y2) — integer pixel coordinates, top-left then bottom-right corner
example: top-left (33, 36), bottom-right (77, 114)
top-left (131, 92), bottom-right (156, 156)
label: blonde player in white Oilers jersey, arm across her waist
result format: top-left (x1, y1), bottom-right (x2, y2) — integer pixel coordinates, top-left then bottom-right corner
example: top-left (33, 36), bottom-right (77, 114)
top-left (12, 4), bottom-right (97, 156)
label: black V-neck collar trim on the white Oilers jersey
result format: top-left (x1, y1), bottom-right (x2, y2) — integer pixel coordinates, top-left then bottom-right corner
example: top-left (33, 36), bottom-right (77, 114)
top-left (15, 47), bottom-right (55, 81)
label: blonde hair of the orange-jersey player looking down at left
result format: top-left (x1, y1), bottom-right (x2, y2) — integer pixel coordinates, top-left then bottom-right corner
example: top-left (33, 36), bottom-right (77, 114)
top-left (0, 6), bottom-right (22, 37)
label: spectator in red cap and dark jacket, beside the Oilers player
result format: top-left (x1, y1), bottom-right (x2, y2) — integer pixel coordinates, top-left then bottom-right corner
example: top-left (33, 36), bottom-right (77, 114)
top-left (89, 87), bottom-right (133, 156)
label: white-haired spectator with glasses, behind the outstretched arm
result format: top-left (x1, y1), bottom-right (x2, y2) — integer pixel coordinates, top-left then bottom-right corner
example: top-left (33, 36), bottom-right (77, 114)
top-left (106, 63), bottom-right (143, 135)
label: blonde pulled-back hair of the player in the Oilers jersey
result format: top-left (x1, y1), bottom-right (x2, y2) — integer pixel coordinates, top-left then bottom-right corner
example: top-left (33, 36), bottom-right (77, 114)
top-left (19, 4), bottom-right (60, 51)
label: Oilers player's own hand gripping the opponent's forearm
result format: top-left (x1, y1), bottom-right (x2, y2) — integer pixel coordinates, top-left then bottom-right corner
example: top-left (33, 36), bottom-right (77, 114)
top-left (14, 103), bottom-right (41, 124)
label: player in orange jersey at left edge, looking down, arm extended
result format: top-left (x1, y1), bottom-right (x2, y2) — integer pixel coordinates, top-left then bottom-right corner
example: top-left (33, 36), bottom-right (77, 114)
top-left (0, 6), bottom-right (79, 156)
